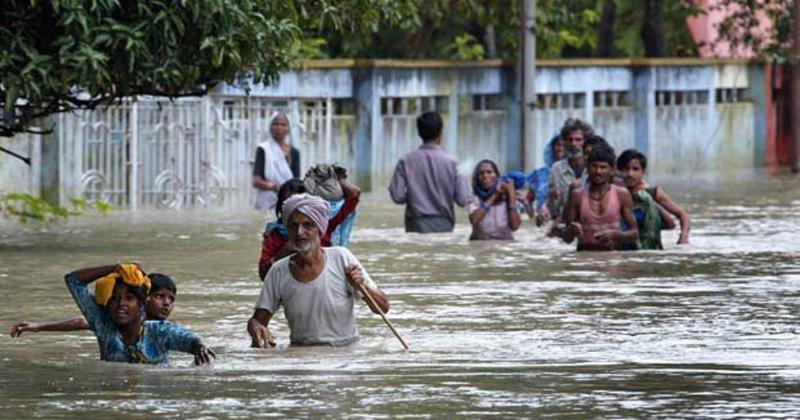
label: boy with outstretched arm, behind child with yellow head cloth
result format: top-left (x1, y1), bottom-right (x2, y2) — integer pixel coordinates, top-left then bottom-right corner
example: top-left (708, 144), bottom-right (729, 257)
top-left (11, 273), bottom-right (178, 337)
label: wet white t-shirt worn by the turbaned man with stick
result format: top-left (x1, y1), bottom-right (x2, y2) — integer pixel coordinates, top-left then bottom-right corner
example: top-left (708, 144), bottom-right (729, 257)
top-left (256, 247), bottom-right (377, 346)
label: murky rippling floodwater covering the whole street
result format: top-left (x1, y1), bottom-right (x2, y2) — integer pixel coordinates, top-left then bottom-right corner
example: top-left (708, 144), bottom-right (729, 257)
top-left (0, 170), bottom-right (800, 419)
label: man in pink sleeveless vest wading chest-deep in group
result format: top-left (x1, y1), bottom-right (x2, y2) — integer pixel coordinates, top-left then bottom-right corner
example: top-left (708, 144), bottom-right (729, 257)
top-left (562, 145), bottom-right (639, 251)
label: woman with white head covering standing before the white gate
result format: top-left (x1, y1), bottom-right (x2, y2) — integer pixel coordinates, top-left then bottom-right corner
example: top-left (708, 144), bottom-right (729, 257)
top-left (253, 112), bottom-right (300, 212)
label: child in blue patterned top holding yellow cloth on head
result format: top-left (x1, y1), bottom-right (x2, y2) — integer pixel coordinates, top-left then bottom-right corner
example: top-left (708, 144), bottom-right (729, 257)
top-left (64, 264), bottom-right (216, 365)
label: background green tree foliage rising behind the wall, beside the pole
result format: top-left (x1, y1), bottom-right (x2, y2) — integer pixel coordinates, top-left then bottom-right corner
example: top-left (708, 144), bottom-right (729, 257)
top-left (305, 0), bottom-right (704, 59)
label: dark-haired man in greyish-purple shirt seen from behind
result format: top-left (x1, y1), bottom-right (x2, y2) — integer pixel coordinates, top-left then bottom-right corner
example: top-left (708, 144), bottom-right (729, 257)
top-left (389, 111), bottom-right (469, 233)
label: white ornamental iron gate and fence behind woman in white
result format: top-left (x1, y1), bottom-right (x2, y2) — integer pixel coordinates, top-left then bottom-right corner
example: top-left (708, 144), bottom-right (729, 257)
top-left (59, 97), bottom-right (355, 209)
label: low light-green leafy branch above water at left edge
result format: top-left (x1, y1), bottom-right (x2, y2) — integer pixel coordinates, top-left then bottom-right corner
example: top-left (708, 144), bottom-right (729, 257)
top-left (0, 193), bottom-right (114, 223)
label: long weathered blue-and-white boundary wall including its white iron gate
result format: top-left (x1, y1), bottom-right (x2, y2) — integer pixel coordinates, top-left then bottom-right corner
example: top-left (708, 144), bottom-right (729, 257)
top-left (0, 59), bottom-right (767, 208)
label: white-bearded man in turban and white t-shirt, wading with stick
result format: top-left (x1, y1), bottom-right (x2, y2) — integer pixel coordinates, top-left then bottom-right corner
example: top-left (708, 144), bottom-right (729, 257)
top-left (247, 194), bottom-right (389, 348)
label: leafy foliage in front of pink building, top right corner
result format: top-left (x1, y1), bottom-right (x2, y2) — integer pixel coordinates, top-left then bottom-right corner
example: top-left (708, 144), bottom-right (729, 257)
top-left (712, 0), bottom-right (797, 61)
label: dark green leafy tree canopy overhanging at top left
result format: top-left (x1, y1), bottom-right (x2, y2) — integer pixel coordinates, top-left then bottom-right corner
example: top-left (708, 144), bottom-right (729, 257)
top-left (0, 0), bottom-right (400, 141)
